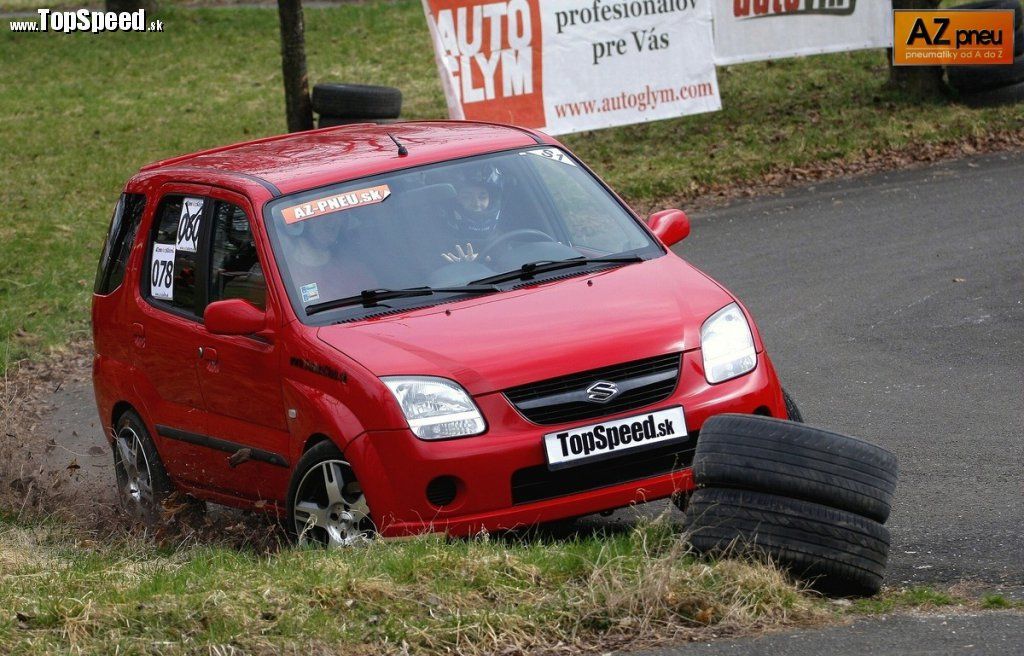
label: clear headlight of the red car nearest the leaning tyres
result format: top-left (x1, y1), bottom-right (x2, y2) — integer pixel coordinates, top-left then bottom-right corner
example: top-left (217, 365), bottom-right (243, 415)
top-left (700, 303), bottom-right (758, 384)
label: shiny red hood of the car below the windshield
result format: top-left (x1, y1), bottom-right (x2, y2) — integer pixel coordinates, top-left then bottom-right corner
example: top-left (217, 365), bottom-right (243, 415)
top-left (318, 253), bottom-right (733, 395)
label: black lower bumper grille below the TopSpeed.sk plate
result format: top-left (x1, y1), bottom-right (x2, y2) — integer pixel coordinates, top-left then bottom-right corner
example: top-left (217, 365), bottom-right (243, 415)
top-left (512, 431), bottom-right (697, 504)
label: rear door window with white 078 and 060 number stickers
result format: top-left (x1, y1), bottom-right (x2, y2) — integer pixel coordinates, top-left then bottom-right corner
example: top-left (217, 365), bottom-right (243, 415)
top-left (148, 195), bottom-right (207, 314)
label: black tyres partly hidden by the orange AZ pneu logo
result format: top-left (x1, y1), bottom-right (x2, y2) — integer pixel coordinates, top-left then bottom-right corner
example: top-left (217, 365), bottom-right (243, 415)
top-left (946, 0), bottom-right (1024, 106)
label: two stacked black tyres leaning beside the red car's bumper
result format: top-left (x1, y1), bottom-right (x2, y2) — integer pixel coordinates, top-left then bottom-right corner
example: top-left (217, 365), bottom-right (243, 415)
top-left (686, 414), bottom-right (898, 595)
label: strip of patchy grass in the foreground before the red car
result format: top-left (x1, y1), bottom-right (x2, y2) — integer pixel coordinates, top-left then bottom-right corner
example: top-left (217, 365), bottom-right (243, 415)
top-left (0, 520), bottom-right (829, 654)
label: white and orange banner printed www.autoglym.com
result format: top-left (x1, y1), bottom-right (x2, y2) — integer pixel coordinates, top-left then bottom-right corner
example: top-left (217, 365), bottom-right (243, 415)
top-left (423, 0), bottom-right (722, 134)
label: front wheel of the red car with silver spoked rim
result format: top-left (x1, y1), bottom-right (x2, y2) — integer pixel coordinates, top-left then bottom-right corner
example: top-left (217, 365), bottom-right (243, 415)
top-left (285, 440), bottom-right (374, 549)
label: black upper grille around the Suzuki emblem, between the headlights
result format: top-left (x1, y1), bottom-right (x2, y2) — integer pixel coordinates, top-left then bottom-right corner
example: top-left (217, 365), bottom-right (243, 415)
top-left (505, 353), bottom-right (680, 425)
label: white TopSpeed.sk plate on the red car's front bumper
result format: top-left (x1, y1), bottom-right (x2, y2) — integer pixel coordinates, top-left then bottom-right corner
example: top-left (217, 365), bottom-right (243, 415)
top-left (544, 406), bottom-right (686, 470)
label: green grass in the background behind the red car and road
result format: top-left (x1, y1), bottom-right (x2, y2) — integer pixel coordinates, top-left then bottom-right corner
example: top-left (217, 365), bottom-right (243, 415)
top-left (0, 0), bottom-right (1024, 367)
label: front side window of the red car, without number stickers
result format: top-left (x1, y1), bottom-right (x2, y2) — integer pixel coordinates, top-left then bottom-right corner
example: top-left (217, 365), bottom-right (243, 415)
top-left (210, 201), bottom-right (266, 310)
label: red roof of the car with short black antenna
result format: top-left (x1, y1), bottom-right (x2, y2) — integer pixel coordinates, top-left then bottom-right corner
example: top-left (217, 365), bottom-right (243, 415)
top-left (140, 121), bottom-right (555, 196)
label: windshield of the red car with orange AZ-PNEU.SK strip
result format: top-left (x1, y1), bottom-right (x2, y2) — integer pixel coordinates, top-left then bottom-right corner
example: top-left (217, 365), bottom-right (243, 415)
top-left (265, 147), bottom-right (664, 323)
